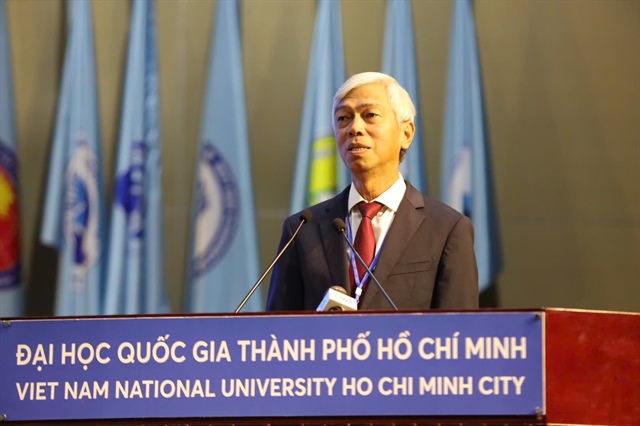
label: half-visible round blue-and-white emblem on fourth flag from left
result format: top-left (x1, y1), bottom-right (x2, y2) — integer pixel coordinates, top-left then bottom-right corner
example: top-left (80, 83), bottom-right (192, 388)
top-left (193, 143), bottom-right (240, 276)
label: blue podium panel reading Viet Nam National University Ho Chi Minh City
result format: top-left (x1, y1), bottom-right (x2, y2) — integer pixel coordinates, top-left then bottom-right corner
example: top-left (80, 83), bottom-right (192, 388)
top-left (0, 312), bottom-right (545, 421)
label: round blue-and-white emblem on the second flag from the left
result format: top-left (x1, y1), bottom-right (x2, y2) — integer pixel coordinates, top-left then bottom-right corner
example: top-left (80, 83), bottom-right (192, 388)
top-left (64, 135), bottom-right (100, 275)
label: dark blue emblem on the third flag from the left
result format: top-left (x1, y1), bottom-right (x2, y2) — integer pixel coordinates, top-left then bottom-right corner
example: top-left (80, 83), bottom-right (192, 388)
top-left (115, 142), bottom-right (146, 238)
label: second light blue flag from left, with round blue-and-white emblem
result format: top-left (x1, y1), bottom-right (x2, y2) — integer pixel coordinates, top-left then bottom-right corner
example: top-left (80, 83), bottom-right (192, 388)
top-left (40, 0), bottom-right (106, 315)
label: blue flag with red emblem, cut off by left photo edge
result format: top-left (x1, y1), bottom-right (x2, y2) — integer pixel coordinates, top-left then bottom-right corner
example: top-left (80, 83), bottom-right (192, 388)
top-left (0, 0), bottom-right (23, 317)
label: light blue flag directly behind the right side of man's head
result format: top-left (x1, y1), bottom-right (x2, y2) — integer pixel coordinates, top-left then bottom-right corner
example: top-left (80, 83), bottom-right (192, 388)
top-left (382, 0), bottom-right (427, 194)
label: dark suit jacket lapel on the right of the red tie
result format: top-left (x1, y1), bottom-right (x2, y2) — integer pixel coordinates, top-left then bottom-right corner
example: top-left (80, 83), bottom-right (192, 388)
top-left (360, 182), bottom-right (425, 309)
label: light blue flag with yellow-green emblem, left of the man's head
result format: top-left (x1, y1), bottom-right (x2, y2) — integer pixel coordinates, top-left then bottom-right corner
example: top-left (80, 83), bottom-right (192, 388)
top-left (290, 0), bottom-right (350, 213)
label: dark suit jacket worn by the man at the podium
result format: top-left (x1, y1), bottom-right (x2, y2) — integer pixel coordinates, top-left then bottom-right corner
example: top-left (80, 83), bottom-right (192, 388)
top-left (267, 182), bottom-right (478, 311)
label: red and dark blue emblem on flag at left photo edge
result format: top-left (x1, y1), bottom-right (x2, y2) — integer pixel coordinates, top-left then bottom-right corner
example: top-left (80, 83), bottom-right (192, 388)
top-left (0, 139), bottom-right (20, 288)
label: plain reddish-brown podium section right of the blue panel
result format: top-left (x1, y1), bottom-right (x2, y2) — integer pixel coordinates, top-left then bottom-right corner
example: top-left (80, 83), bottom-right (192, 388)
top-left (545, 309), bottom-right (640, 425)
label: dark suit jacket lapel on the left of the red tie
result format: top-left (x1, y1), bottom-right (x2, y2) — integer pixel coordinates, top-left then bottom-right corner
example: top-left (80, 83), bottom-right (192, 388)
top-left (319, 187), bottom-right (351, 294)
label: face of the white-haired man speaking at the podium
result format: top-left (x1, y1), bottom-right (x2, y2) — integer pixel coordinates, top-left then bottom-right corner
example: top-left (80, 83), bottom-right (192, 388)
top-left (333, 83), bottom-right (414, 179)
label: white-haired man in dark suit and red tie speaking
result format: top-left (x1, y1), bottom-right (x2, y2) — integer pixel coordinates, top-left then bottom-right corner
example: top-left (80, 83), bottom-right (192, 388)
top-left (267, 73), bottom-right (478, 311)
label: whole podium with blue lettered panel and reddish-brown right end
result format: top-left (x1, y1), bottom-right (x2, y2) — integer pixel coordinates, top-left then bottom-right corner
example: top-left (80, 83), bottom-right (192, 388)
top-left (0, 309), bottom-right (640, 425)
